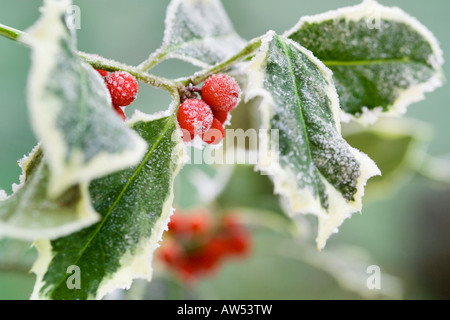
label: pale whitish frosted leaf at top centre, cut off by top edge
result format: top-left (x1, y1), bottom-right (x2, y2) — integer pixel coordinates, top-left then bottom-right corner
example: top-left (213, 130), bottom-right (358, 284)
top-left (141, 0), bottom-right (245, 69)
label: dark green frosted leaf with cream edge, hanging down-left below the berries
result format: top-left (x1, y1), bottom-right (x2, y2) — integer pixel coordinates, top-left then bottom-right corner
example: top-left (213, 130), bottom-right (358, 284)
top-left (32, 113), bottom-right (184, 299)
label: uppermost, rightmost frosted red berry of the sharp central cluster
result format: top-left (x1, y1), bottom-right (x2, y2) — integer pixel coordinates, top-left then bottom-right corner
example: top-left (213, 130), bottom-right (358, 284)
top-left (201, 74), bottom-right (241, 112)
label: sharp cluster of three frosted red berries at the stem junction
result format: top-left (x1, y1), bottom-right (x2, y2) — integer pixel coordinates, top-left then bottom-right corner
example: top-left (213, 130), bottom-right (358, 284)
top-left (177, 74), bottom-right (241, 144)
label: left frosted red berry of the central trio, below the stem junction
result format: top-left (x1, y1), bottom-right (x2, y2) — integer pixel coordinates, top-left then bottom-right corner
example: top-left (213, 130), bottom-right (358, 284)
top-left (177, 99), bottom-right (214, 135)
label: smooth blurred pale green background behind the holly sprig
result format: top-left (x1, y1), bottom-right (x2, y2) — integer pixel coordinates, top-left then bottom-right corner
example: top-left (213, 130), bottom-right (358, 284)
top-left (0, 0), bottom-right (450, 299)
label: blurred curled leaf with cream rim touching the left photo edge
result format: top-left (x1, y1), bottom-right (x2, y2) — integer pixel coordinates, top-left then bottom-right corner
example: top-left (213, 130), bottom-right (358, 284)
top-left (0, 147), bottom-right (99, 240)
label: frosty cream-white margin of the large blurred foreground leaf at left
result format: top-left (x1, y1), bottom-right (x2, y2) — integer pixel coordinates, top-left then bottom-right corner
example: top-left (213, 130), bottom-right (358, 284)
top-left (22, 0), bottom-right (147, 198)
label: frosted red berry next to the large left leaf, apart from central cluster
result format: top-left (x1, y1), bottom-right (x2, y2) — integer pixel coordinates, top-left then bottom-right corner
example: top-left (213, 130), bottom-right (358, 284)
top-left (106, 71), bottom-right (139, 107)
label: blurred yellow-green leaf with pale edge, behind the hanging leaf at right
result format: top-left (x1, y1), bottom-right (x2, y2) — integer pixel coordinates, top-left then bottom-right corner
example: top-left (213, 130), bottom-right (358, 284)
top-left (342, 117), bottom-right (432, 200)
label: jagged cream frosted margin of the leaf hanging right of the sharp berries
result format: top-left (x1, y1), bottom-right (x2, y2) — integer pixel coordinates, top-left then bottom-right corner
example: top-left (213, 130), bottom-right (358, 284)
top-left (245, 31), bottom-right (381, 249)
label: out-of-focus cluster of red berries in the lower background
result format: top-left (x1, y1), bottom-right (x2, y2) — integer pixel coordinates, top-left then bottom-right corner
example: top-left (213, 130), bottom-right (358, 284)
top-left (157, 210), bottom-right (250, 284)
